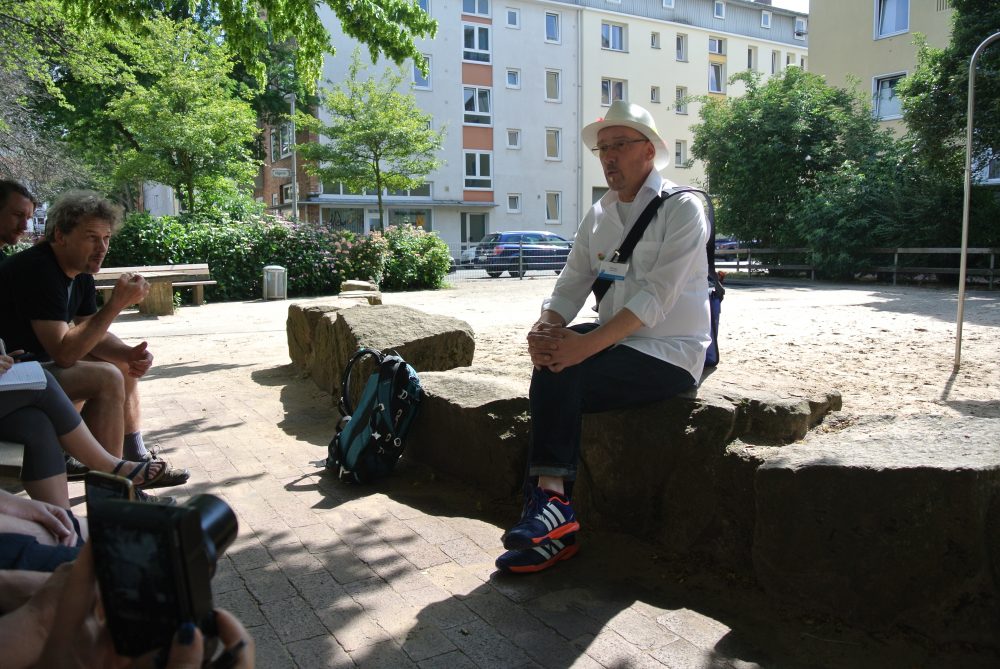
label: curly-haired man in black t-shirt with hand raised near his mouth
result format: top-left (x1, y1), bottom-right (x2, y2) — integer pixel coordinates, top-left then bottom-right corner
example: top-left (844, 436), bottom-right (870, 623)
top-left (0, 191), bottom-right (189, 485)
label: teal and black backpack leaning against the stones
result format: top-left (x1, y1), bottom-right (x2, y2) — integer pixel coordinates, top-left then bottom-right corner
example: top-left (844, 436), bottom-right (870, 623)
top-left (326, 348), bottom-right (424, 483)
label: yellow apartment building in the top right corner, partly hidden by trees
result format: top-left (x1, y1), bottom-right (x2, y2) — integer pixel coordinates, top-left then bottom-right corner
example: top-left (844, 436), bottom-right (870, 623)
top-left (809, 0), bottom-right (952, 133)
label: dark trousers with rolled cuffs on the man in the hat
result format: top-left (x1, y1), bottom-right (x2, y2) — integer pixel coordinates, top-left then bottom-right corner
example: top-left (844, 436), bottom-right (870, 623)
top-left (528, 323), bottom-right (695, 481)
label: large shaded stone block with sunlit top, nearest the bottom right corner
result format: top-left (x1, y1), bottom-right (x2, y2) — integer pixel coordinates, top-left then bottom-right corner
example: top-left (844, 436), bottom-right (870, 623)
top-left (745, 416), bottom-right (1000, 642)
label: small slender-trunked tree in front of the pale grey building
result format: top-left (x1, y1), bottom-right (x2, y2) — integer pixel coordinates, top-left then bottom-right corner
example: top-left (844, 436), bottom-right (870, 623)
top-left (296, 51), bottom-right (444, 230)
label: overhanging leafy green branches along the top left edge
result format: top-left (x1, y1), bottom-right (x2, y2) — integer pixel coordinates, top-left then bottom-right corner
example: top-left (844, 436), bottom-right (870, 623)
top-left (60, 0), bottom-right (437, 90)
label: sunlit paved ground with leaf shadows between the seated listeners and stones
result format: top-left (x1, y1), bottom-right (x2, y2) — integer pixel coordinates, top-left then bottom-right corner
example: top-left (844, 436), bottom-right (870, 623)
top-left (48, 288), bottom-right (976, 669)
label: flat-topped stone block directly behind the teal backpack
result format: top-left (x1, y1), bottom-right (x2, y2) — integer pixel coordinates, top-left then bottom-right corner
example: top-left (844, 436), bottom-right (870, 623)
top-left (306, 305), bottom-right (476, 397)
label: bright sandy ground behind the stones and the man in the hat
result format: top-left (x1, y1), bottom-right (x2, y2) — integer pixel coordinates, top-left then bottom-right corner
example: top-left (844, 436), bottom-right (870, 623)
top-left (376, 273), bottom-right (1000, 418)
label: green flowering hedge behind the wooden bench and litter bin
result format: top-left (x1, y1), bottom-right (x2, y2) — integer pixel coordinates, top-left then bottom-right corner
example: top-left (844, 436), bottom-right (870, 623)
top-left (104, 213), bottom-right (450, 301)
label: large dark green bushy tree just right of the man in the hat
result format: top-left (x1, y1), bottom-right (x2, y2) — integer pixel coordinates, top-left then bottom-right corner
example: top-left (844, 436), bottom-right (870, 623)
top-left (692, 68), bottom-right (892, 246)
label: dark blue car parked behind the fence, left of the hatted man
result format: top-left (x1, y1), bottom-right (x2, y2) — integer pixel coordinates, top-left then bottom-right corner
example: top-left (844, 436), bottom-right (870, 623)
top-left (475, 230), bottom-right (573, 279)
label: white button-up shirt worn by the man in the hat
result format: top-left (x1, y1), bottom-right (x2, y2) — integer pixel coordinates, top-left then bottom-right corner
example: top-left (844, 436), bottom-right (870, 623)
top-left (542, 170), bottom-right (711, 381)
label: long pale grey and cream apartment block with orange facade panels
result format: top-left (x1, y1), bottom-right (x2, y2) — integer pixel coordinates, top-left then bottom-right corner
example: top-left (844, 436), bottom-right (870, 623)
top-left (258, 0), bottom-right (808, 256)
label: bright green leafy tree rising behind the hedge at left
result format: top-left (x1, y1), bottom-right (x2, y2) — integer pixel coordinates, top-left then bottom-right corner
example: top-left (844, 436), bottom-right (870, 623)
top-left (106, 17), bottom-right (257, 211)
